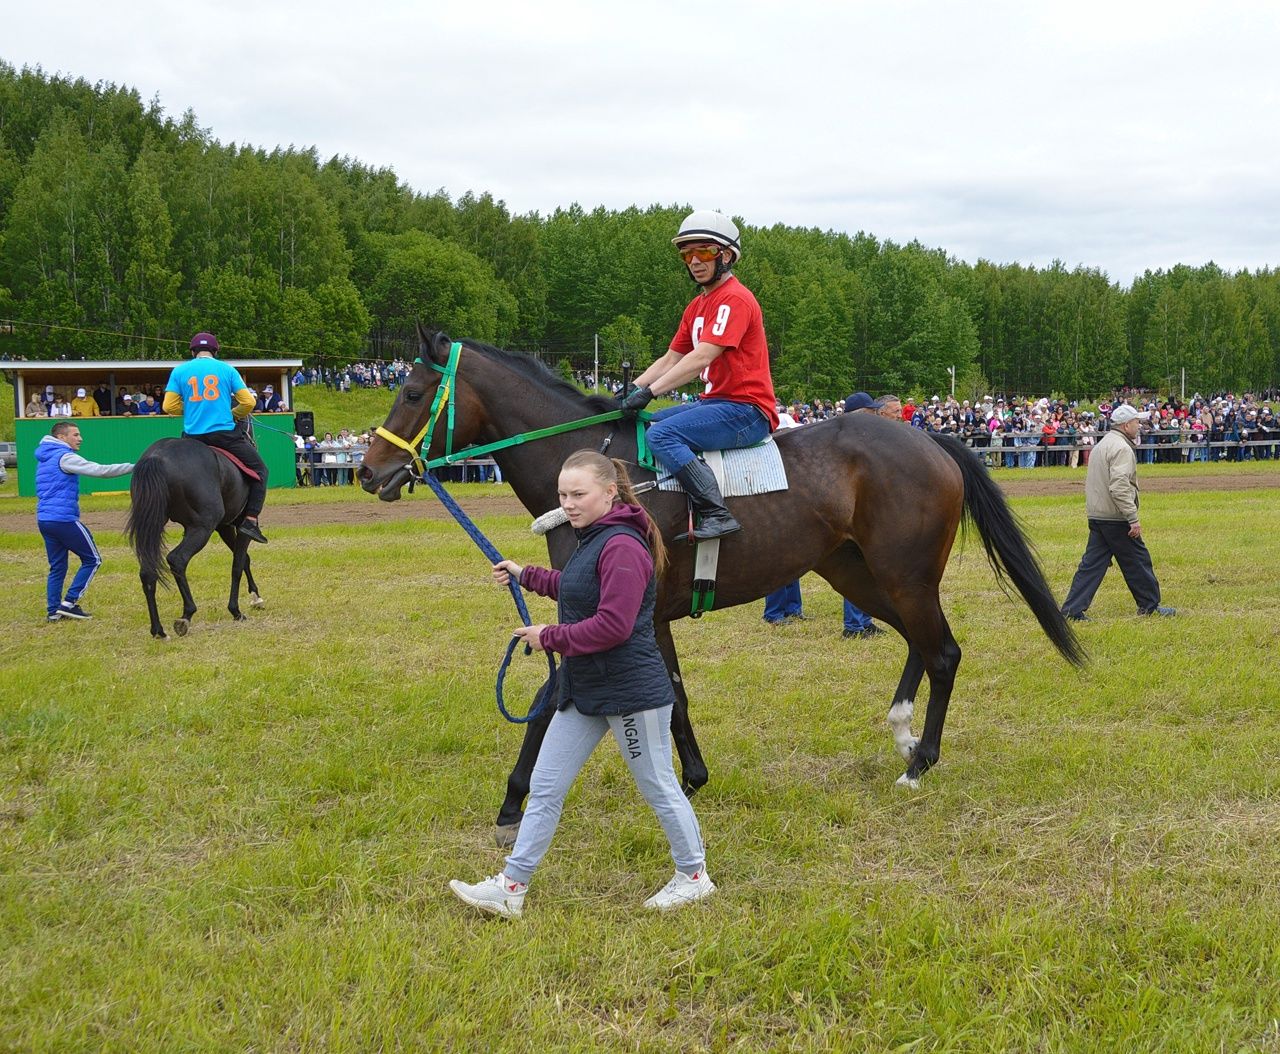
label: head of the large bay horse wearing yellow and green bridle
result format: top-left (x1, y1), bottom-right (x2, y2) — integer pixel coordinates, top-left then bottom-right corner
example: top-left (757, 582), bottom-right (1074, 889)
top-left (358, 324), bottom-right (457, 501)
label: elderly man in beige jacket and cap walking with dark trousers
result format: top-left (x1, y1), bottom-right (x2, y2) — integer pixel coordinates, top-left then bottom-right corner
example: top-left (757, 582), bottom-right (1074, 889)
top-left (1062, 402), bottom-right (1176, 622)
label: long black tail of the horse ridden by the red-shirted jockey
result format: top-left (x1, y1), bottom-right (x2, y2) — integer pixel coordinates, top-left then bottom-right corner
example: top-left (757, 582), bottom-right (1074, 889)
top-left (929, 433), bottom-right (1088, 666)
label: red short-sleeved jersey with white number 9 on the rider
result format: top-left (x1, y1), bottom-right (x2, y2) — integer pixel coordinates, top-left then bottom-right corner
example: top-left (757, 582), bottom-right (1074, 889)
top-left (671, 275), bottom-right (778, 432)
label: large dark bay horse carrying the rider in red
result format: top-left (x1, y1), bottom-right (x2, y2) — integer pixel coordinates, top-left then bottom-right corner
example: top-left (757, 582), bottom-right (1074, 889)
top-left (358, 327), bottom-right (1084, 838)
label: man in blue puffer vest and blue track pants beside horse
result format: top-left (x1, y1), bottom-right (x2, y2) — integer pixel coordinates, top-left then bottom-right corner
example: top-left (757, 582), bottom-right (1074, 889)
top-left (36, 421), bottom-right (133, 622)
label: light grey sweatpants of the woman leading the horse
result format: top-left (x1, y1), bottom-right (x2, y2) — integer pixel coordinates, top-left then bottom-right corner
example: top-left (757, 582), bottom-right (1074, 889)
top-left (503, 704), bottom-right (707, 882)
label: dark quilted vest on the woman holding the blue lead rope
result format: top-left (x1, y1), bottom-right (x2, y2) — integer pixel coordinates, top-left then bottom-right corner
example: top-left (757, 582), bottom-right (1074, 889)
top-left (558, 524), bottom-right (676, 716)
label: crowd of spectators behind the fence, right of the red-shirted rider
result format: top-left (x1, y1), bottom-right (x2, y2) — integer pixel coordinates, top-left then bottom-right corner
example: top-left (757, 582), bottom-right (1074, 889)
top-left (778, 391), bottom-right (1280, 469)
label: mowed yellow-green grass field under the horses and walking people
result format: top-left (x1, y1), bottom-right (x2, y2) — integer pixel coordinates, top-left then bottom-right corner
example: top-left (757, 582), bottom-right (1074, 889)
top-left (0, 488), bottom-right (1280, 1051)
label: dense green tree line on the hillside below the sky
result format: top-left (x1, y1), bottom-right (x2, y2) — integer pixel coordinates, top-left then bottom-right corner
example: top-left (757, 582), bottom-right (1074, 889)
top-left (0, 61), bottom-right (1280, 398)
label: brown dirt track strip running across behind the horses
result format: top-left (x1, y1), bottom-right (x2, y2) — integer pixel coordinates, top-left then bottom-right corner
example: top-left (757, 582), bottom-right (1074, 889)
top-left (0, 464), bottom-right (1280, 531)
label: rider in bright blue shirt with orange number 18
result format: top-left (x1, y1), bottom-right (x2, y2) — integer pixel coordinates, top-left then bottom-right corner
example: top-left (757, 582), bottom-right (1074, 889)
top-left (164, 333), bottom-right (266, 542)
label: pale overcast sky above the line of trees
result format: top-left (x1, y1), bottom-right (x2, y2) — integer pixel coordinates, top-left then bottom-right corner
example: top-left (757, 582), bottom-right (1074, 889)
top-left (0, 0), bottom-right (1280, 286)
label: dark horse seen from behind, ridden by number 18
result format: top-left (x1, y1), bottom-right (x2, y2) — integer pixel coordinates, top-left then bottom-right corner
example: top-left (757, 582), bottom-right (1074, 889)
top-left (125, 438), bottom-right (262, 640)
